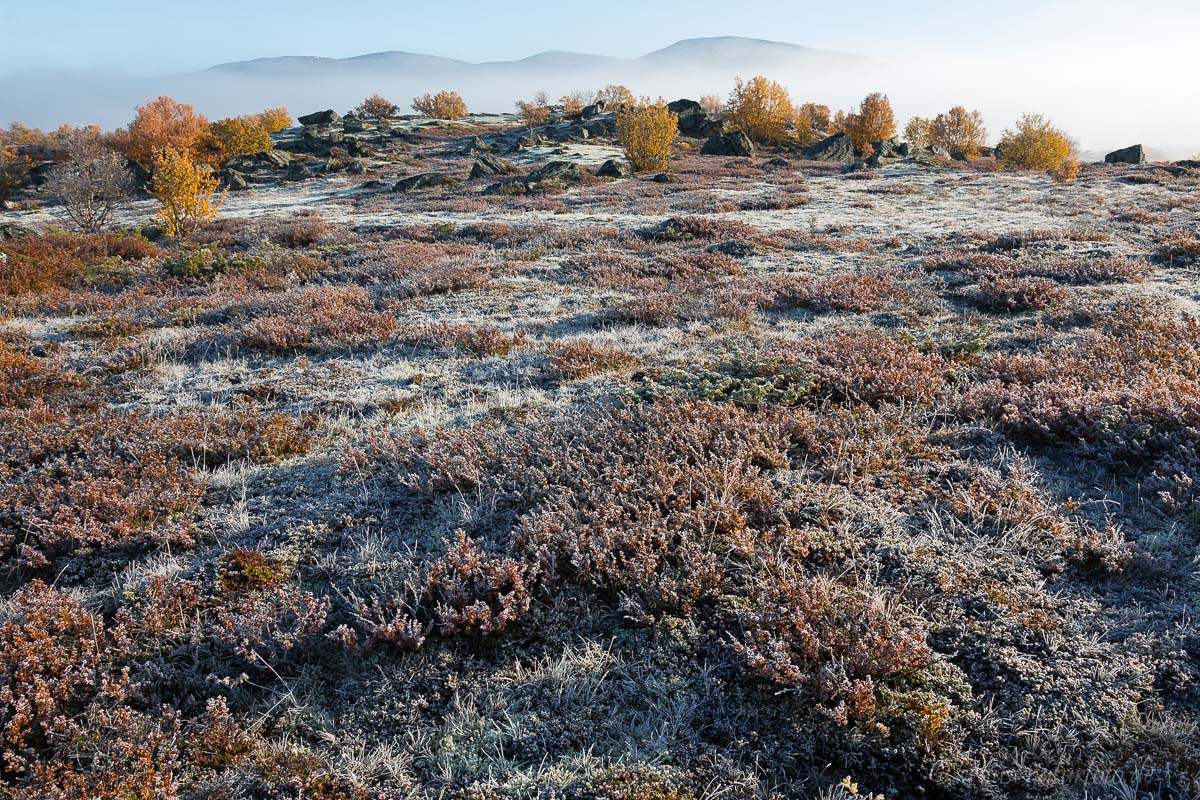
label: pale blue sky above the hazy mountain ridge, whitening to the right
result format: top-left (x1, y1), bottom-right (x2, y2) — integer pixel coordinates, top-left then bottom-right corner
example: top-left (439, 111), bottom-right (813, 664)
top-left (0, 0), bottom-right (1200, 74)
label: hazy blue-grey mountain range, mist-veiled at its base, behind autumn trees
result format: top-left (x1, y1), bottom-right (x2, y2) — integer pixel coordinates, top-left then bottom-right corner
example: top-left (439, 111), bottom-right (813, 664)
top-left (0, 36), bottom-right (870, 127)
